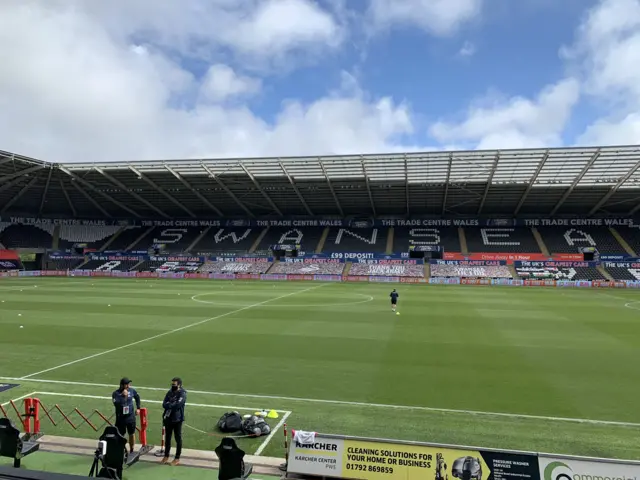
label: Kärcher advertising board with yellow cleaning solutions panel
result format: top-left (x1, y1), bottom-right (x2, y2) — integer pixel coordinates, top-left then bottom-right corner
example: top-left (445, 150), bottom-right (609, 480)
top-left (287, 434), bottom-right (540, 480)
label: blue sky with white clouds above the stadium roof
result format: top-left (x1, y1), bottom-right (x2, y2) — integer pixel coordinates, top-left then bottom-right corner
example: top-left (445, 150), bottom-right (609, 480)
top-left (0, 0), bottom-right (640, 162)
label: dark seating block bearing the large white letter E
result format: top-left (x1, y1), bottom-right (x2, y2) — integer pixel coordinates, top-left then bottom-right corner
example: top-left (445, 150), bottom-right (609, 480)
top-left (464, 227), bottom-right (540, 253)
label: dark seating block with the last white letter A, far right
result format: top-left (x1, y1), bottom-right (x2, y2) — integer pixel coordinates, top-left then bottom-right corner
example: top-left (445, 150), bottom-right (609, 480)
top-left (538, 227), bottom-right (626, 255)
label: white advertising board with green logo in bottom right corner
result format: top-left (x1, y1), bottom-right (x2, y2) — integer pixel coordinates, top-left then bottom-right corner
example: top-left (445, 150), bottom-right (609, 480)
top-left (538, 455), bottom-right (640, 480)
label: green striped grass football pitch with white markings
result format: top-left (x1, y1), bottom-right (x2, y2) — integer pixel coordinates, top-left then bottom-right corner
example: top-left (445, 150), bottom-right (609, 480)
top-left (0, 278), bottom-right (640, 459)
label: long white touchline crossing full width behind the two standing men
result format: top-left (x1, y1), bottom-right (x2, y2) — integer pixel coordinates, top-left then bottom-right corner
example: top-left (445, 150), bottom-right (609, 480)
top-left (0, 377), bottom-right (640, 427)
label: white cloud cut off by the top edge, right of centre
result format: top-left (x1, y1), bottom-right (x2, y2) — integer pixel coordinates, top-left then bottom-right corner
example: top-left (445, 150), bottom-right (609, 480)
top-left (370, 0), bottom-right (483, 36)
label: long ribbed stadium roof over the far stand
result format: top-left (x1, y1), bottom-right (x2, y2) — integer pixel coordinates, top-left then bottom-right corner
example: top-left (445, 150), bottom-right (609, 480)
top-left (0, 145), bottom-right (640, 218)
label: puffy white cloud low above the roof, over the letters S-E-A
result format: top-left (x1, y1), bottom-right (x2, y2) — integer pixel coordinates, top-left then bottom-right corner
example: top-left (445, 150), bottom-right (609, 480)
top-left (430, 78), bottom-right (579, 149)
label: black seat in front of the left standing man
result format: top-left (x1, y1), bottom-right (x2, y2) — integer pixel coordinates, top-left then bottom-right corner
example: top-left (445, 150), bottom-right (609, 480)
top-left (89, 425), bottom-right (140, 480)
